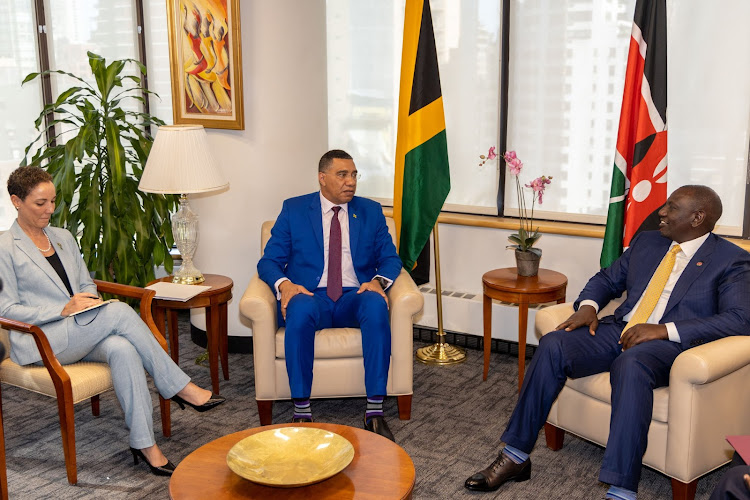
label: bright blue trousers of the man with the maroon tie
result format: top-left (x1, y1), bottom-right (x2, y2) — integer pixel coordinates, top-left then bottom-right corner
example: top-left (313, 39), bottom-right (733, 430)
top-left (279, 287), bottom-right (391, 399)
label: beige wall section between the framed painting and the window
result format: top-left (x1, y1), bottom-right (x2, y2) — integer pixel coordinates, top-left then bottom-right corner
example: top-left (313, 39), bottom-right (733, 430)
top-left (191, 0), bottom-right (328, 335)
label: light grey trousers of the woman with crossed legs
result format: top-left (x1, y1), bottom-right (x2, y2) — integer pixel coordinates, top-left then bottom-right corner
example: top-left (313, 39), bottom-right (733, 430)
top-left (51, 302), bottom-right (190, 449)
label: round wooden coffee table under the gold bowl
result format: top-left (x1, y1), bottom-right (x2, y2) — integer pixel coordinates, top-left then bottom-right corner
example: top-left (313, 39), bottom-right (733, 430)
top-left (169, 422), bottom-right (415, 500)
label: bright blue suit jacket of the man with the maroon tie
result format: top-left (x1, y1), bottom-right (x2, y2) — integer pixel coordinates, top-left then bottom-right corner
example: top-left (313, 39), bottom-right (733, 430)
top-left (258, 192), bottom-right (401, 291)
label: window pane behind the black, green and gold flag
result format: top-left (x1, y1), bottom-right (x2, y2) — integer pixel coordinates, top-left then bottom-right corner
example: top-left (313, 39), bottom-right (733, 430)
top-left (326, 0), bottom-right (500, 214)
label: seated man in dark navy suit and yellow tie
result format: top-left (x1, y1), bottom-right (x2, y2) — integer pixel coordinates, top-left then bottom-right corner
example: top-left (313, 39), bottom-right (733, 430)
top-left (465, 186), bottom-right (750, 500)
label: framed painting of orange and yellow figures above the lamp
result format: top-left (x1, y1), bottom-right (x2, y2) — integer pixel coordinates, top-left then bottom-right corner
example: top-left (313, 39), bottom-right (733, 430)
top-left (167, 0), bottom-right (245, 130)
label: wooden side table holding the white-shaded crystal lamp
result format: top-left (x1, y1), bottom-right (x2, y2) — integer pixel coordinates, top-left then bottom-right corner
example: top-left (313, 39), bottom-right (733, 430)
top-left (149, 274), bottom-right (234, 394)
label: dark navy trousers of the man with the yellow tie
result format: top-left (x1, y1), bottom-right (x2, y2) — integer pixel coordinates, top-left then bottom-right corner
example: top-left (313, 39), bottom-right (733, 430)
top-left (501, 321), bottom-right (682, 491)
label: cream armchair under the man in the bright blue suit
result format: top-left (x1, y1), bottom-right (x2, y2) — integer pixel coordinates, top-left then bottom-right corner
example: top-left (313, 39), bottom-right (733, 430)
top-left (240, 218), bottom-right (424, 425)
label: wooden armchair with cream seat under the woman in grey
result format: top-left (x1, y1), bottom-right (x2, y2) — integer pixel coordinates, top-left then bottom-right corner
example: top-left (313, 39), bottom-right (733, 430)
top-left (0, 280), bottom-right (171, 484)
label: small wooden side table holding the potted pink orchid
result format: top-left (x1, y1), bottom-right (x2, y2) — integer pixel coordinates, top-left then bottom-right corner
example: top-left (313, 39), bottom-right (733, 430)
top-left (482, 267), bottom-right (568, 391)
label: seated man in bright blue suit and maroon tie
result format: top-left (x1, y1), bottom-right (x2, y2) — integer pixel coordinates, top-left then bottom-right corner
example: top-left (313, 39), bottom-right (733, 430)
top-left (258, 149), bottom-right (401, 440)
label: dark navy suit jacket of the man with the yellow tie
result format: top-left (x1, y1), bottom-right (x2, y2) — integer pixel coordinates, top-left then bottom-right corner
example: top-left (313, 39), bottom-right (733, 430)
top-left (575, 231), bottom-right (750, 349)
